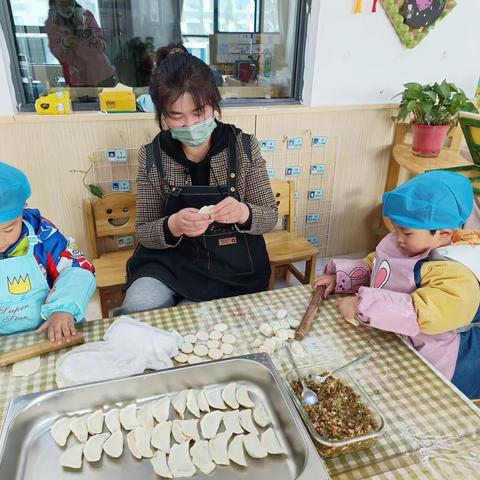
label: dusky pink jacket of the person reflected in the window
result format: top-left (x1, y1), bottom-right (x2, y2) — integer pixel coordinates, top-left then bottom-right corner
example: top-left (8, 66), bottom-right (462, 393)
top-left (45, 10), bottom-right (115, 87)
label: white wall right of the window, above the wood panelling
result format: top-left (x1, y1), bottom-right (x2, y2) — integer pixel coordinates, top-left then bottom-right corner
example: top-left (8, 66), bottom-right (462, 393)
top-left (303, 0), bottom-right (480, 106)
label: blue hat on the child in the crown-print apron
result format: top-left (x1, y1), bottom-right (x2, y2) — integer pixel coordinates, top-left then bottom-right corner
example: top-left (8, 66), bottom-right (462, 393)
top-left (0, 162), bottom-right (32, 223)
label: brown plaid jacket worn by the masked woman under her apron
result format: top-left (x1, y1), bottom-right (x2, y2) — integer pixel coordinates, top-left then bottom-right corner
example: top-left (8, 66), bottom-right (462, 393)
top-left (136, 131), bottom-right (278, 249)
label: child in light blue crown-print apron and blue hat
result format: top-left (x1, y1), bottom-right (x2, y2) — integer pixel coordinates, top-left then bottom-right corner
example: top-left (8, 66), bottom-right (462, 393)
top-left (0, 162), bottom-right (95, 344)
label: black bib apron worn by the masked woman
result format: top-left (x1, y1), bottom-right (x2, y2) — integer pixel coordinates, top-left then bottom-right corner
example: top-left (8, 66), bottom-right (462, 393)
top-left (126, 128), bottom-right (270, 301)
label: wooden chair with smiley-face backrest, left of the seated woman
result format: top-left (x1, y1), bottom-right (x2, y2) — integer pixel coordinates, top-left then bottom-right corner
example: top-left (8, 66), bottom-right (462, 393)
top-left (83, 193), bottom-right (137, 318)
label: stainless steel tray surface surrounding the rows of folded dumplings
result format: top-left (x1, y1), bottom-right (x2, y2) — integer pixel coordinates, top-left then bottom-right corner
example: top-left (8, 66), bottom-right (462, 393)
top-left (0, 354), bottom-right (329, 480)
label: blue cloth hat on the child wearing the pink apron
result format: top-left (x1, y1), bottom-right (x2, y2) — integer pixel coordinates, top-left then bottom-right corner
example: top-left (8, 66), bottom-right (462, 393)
top-left (383, 170), bottom-right (473, 230)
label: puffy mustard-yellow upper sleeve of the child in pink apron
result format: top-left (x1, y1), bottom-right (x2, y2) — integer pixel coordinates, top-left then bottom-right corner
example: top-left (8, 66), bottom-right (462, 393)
top-left (412, 261), bottom-right (480, 334)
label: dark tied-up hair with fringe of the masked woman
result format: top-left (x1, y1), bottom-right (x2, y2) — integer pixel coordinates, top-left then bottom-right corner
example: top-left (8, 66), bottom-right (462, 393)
top-left (150, 43), bottom-right (221, 129)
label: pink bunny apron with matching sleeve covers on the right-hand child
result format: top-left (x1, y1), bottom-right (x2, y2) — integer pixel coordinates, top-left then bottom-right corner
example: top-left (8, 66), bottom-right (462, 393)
top-left (325, 234), bottom-right (460, 380)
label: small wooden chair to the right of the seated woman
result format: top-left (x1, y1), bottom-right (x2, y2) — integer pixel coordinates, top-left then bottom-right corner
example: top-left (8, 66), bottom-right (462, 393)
top-left (264, 179), bottom-right (318, 290)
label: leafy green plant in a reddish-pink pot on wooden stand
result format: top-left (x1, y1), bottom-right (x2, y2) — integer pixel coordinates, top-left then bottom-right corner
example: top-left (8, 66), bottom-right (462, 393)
top-left (392, 80), bottom-right (477, 157)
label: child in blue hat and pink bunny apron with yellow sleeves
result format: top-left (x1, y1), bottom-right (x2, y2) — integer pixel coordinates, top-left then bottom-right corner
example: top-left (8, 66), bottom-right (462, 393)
top-left (314, 170), bottom-right (480, 398)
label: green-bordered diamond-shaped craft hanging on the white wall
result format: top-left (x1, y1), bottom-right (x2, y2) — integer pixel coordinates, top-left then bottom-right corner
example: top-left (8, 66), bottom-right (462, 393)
top-left (380, 0), bottom-right (457, 48)
